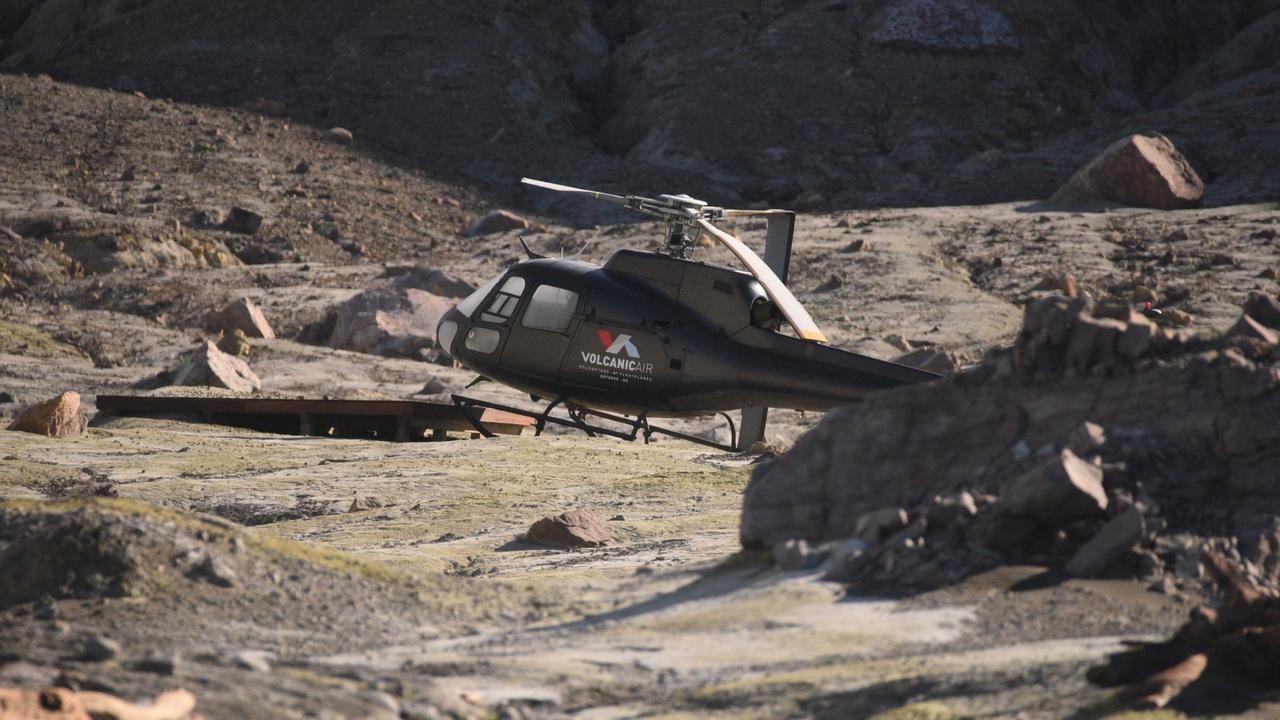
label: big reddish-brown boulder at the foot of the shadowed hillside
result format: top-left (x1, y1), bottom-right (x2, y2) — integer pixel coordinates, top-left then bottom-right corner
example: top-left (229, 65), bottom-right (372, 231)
top-left (1050, 132), bottom-right (1204, 210)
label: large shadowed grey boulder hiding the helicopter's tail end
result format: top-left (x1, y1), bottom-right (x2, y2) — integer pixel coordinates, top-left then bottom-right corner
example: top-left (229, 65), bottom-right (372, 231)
top-left (740, 311), bottom-right (1280, 548)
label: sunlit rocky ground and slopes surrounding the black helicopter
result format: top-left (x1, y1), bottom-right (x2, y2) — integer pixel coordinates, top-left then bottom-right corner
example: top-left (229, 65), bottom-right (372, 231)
top-left (0, 0), bottom-right (1280, 719)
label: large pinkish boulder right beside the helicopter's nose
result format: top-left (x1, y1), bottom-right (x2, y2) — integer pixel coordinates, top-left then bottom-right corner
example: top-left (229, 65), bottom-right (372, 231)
top-left (329, 287), bottom-right (453, 360)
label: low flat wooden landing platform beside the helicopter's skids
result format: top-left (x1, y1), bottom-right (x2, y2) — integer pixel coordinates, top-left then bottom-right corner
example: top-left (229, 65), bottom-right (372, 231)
top-left (97, 395), bottom-right (534, 442)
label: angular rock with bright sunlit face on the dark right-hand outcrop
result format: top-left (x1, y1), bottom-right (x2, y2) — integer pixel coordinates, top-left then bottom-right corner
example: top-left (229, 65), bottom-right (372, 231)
top-left (1000, 448), bottom-right (1107, 525)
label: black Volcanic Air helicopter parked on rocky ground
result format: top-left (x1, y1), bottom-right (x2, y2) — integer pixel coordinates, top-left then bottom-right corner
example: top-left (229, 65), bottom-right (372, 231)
top-left (436, 178), bottom-right (938, 450)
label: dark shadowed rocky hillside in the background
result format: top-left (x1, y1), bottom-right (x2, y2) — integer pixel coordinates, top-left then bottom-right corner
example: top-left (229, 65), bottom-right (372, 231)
top-left (0, 0), bottom-right (1280, 213)
